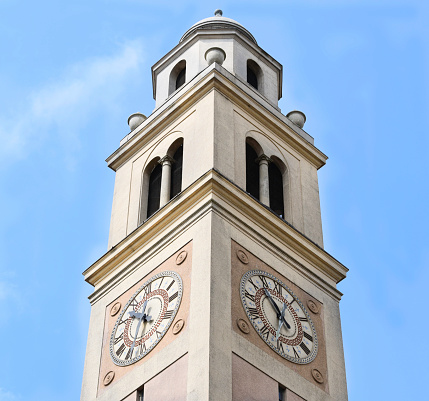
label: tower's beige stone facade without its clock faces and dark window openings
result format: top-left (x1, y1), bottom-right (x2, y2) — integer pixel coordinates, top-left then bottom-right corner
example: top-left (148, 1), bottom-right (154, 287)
top-left (81, 10), bottom-right (347, 401)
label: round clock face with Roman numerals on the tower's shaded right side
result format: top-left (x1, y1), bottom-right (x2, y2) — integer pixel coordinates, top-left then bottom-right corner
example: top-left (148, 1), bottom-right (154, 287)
top-left (240, 270), bottom-right (318, 364)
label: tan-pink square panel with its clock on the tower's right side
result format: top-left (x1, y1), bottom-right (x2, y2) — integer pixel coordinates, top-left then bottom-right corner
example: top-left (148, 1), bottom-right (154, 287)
top-left (231, 241), bottom-right (329, 392)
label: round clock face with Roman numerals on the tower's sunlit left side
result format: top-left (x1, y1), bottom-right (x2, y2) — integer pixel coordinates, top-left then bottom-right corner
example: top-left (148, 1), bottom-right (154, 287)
top-left (110, 271), bottom-right (182, 366)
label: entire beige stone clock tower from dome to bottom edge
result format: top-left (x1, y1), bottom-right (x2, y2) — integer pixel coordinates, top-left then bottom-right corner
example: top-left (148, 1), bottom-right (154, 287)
top-left (81, 10), bottom-right (347, 401)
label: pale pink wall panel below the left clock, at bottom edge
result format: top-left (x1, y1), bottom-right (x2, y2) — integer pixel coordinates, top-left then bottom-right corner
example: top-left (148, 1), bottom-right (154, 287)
top-left (144, 355), bottom-right (188, 401)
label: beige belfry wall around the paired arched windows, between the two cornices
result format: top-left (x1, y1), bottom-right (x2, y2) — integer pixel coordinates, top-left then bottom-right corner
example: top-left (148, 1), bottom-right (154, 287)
top-left (108, 69), bottom-right (323, 249)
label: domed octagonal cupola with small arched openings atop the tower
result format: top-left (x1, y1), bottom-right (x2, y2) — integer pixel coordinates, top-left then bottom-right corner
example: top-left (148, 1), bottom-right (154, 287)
top-left (152, 10), bottom-right (282, 108)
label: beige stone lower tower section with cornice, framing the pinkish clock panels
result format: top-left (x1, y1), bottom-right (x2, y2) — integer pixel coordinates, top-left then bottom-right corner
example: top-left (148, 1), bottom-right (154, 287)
top-left (81, 173), bottom-right (347, 401)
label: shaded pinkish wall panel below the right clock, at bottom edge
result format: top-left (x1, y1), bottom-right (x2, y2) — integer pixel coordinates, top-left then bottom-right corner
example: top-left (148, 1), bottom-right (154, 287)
top-left (231, 354), bottom-right (279, 401)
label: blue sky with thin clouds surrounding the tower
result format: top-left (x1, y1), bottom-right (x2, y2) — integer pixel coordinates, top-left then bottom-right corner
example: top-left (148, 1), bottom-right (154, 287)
top-left (0, 0), bottom-right (429, 401)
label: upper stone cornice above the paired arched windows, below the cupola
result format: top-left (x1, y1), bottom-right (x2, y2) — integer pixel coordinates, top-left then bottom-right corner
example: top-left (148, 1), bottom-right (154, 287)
top-left (106, 63), bottom-right (327, 171)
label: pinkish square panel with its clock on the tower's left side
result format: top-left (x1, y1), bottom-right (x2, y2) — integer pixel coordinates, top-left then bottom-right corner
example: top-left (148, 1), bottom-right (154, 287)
top-left (98, 243), bottom-right (192, 393)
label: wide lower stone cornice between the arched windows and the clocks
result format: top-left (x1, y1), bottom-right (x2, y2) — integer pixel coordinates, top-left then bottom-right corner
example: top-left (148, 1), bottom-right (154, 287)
top-left (83, 170), bottom-right (348, 302)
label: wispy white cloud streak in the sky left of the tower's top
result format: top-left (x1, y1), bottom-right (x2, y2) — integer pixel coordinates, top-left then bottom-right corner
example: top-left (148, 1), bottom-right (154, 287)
top-left (0, 40), bottom-right (143, 170)
